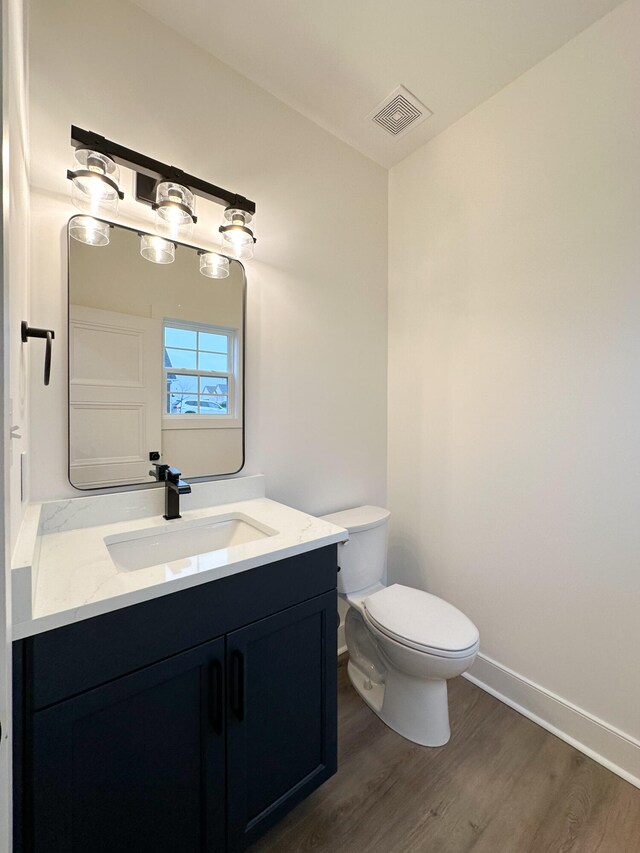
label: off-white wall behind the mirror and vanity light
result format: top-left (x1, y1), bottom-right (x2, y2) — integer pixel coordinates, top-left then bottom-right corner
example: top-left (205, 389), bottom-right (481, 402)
top-left (30, 0), bottom-right (387, 513)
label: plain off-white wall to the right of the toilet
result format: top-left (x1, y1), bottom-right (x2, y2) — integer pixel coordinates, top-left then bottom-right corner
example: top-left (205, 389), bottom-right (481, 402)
top-left (389, 0), bottom-right (640, 764)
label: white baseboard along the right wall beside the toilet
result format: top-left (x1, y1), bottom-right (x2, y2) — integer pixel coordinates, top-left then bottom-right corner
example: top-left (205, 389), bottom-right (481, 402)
top-left (464, 654), bottom-right (640, 788)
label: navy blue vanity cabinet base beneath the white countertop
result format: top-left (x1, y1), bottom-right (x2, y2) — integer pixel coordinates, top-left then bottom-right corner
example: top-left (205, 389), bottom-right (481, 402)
top-left (14, 546), bottom-right (337, 853)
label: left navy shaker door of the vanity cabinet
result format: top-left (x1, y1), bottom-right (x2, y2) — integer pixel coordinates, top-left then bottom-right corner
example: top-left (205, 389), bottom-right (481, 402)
top-left (29, 639), bottom-right (225, 853)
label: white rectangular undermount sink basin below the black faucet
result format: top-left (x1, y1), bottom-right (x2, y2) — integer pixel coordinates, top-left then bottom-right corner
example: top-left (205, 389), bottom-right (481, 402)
top-left (104, 513), bottom-right (277, 574)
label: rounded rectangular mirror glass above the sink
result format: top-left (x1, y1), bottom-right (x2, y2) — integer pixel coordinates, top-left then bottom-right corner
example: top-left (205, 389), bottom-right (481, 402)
top-left (68, 220), bottom-right (246, 489)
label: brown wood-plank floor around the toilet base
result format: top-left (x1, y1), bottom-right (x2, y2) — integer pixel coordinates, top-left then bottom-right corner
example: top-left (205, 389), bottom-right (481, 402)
top-left (251, 656), bottom-right (640, 853)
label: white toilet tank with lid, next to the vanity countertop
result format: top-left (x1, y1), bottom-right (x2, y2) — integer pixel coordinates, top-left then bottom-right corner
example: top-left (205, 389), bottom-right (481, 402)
top-left (322, 506), bottom-right (391, 595)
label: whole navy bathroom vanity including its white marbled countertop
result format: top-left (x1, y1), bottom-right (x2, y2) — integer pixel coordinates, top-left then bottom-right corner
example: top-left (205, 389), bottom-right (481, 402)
top-left (14, 477), bottom-right (346, 853)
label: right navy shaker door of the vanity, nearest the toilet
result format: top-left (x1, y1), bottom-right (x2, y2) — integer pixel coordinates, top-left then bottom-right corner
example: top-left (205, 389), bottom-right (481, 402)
top-left (227, 592), bottom-right (337, 851)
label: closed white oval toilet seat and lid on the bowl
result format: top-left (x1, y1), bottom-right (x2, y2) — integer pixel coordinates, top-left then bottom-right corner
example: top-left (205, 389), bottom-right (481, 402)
top-left (363, 584), bottom-right (479, 658)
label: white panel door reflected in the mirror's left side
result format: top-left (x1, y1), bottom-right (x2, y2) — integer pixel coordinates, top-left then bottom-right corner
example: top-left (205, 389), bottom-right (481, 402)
top-left (69, 305), bottom-right (163, 488)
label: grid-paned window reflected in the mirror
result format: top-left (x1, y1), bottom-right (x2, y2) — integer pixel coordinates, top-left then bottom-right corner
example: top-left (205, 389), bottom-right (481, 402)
top-left (163, 320), bottom-right (237, 420)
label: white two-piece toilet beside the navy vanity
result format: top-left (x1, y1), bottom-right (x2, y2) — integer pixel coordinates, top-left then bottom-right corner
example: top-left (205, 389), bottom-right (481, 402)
top-left (324, 506), bottom-right (480, 746)
